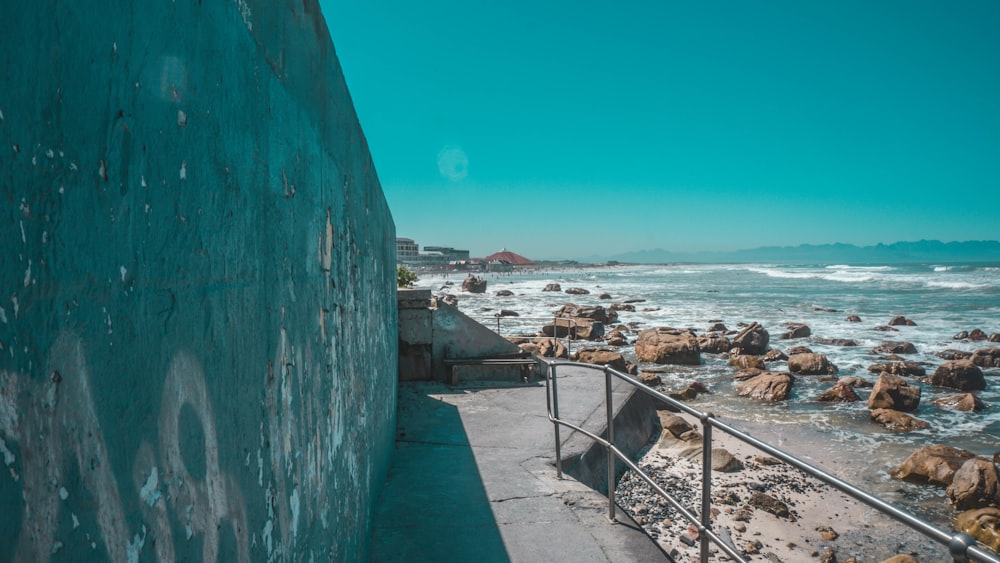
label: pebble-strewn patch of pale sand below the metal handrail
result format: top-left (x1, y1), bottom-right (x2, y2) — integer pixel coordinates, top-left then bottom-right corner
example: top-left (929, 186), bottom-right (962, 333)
top-left (617, 411), bottom-right (951, 562)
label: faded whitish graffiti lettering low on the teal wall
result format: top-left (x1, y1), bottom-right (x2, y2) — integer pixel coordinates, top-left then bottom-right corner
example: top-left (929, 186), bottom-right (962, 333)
top-left (0, 335), bottom-right (250, 562)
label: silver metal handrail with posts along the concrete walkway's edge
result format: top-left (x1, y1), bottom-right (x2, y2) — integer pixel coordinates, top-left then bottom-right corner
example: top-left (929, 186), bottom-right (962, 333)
top-left (541, 358), bottom-right (1000, 563)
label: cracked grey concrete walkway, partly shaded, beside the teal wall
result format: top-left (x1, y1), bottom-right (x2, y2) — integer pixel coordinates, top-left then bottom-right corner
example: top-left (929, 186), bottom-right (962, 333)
top-left (370, 368), bottom-right (669, 562)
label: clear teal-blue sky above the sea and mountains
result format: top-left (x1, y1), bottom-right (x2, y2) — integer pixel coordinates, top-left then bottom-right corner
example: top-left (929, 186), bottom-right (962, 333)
top-left (320, 0), bottom-right (1000, 258)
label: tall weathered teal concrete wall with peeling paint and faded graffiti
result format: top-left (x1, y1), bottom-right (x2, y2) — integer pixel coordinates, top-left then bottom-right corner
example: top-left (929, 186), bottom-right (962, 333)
top-left (0, 0), bottom-right (397, 561)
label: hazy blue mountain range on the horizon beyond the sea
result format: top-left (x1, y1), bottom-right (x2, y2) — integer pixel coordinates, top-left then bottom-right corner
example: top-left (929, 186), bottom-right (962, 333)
top-left (588, 240), bottom-right (1000, 264)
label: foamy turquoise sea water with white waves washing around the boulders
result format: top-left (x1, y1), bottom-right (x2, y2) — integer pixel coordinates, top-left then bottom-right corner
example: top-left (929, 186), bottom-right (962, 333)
top-left (417, 264), bottom-right (1000, 527)
